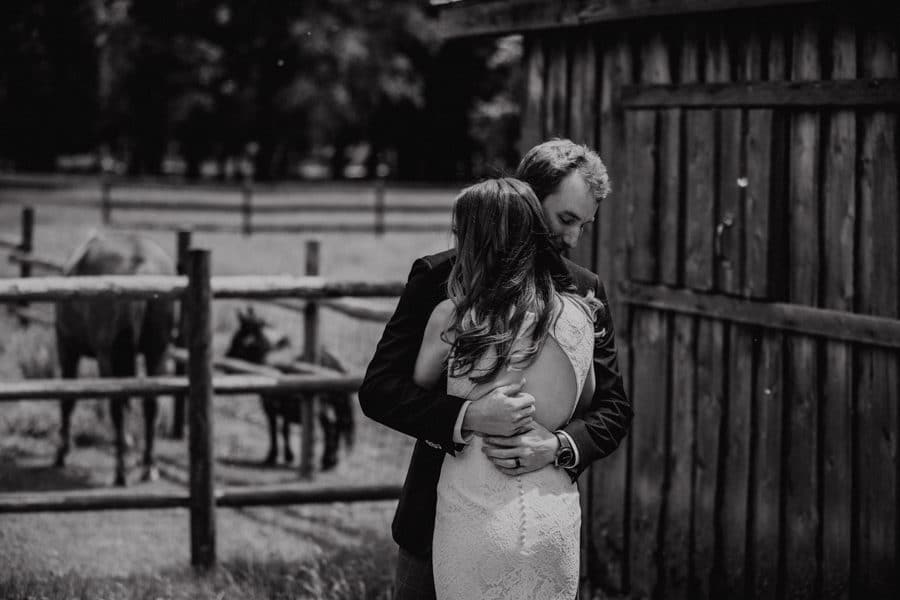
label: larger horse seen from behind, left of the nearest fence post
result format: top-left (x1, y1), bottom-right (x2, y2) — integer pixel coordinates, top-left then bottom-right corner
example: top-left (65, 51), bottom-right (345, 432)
top-left (56, 232), bottom-right (175, 486)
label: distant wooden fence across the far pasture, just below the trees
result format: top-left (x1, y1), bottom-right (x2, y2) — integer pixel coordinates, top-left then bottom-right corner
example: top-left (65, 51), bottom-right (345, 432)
top-left (100, 177), bottom-right (450, 235)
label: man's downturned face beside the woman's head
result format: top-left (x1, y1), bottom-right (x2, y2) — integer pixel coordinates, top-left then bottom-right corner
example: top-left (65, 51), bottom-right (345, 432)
top-left (543, 171), bottom-right (597, 251)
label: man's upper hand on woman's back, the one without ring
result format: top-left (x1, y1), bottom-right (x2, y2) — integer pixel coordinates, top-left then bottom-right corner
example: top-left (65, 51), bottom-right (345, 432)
top-left (462, 379), bottom-right (534, 436)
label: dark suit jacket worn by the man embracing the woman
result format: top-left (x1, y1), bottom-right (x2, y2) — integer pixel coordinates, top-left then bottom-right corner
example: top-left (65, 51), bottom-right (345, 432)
top-left (359, 250), bottom-right (633, 556)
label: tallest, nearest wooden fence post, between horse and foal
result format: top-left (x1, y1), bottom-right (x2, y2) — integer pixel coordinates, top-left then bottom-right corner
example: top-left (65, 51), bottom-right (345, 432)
top-left (184, 250), bottom-right (216, 569)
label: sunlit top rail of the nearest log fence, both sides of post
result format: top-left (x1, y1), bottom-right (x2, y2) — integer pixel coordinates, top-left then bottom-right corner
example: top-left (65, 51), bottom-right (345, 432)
top-left (0, 275), bottom-right (405, 302)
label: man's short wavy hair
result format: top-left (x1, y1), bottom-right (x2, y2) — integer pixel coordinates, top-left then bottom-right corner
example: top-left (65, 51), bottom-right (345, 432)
top-left (516, 138), bottom-right (612, 202)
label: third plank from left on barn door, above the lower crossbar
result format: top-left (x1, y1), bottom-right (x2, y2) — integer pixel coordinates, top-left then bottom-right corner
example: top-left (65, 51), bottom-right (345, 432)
top-left (681, 29), bottom-right (715, 290)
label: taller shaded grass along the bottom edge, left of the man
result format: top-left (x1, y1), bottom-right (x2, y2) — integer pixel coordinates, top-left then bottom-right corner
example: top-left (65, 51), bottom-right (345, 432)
top-left (0, 539), bottom-right (396, 600)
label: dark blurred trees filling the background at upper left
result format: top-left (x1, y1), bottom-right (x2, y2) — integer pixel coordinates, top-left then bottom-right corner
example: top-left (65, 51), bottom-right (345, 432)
top-left (0, 0), bottom-right (522, 181)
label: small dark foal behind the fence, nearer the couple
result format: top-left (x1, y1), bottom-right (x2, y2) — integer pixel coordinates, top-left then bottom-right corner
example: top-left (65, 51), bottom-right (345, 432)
top-left (226, 308), bottom-right (355, 471)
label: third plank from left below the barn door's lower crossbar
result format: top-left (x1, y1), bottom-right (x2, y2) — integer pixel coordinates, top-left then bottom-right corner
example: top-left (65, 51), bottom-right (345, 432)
top-left (689, 319), bottom-right (725, 599)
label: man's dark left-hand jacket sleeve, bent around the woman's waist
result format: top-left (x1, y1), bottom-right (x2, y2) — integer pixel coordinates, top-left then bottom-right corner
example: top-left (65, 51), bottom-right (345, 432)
top-left (359, 259), bottom-right (464, 453)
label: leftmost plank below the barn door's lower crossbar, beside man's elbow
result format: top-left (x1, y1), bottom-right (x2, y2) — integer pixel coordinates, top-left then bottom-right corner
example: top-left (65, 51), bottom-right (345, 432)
top-left (630, 309), bottom-right (669, 598)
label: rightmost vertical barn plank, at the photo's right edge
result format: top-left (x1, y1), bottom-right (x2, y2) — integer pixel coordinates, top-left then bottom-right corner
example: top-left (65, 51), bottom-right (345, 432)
top-left (854, 24), bottom-right (900, 598)
